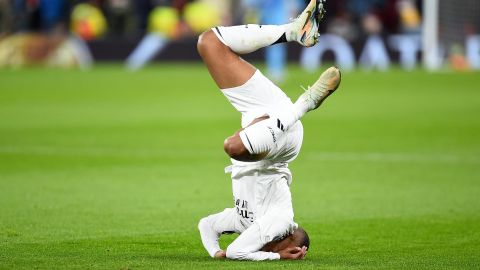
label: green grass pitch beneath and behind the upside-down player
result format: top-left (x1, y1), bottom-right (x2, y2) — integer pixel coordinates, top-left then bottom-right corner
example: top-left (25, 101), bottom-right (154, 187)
top-left (0, 64), bottom-right (480, 269)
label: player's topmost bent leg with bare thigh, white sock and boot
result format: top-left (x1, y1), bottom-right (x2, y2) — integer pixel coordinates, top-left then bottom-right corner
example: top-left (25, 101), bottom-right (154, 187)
top-left (197, 0), bottom-right (325, 89)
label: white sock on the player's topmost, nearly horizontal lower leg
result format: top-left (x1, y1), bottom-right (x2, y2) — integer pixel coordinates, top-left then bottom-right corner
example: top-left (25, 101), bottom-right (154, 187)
top-left (212, 24), bottom-right (292, 54)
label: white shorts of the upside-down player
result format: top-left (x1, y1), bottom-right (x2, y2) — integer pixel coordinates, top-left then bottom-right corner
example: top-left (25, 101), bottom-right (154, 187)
top-left (222, 70), bottom-right (303, 163)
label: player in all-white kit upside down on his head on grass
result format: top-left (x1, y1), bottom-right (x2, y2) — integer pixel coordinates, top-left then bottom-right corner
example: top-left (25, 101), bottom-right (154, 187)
top-left (198, 0), bottom-right (341, 261)
